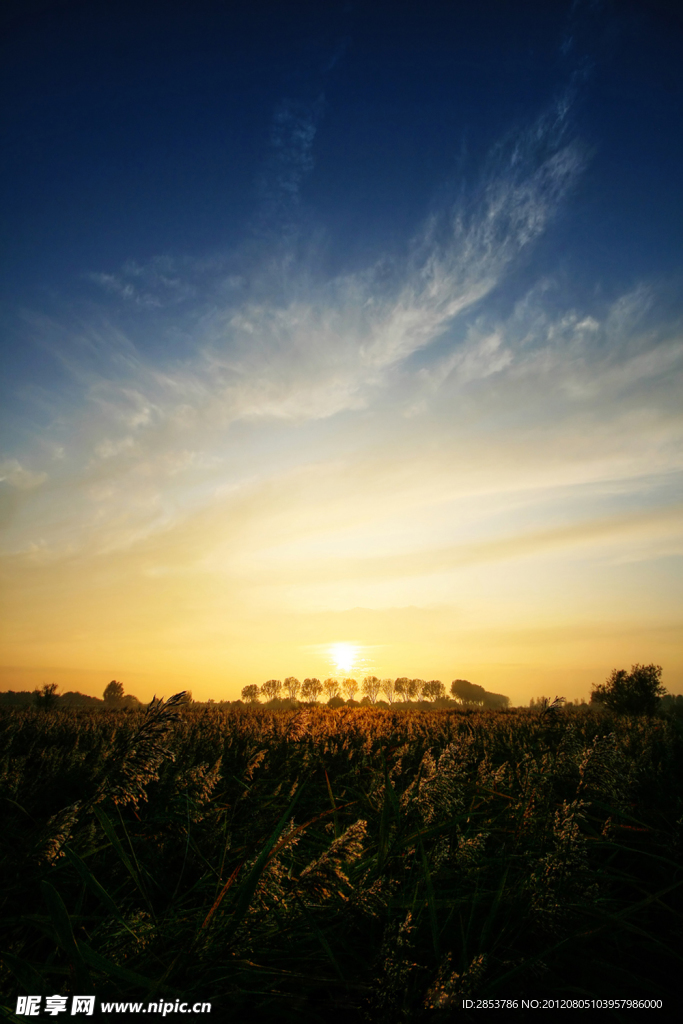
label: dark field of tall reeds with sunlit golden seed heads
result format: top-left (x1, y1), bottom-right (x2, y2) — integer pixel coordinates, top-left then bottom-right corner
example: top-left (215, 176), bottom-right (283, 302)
top-left (0, 698), bottom-right (683, 1024)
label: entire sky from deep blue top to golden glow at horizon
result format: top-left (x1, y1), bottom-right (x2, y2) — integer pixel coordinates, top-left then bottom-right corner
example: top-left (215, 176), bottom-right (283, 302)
top-left (0, 0), bottom-right (683, 705)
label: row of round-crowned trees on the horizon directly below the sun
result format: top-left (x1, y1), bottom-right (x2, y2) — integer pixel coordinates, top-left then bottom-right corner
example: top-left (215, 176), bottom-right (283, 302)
top-left (242, 676), bottom-right (510, 710)
